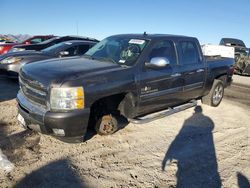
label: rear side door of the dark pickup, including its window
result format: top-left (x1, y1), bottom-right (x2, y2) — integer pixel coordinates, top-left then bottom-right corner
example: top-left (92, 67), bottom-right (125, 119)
top-left (178, 40), bottom-right (206, 100)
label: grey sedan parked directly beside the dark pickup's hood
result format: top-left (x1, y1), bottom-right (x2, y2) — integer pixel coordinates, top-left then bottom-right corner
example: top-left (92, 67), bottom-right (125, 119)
top-left (0, 40), bottom-right (97, 78)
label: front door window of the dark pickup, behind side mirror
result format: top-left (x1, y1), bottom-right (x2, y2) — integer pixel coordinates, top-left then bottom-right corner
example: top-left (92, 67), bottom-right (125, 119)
top-left (148, 41), bottom-right (176, 65)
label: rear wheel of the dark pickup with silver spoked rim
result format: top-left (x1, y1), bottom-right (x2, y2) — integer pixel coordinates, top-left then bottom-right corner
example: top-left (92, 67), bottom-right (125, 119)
top-left (201, 80), bottom-right (224, 107)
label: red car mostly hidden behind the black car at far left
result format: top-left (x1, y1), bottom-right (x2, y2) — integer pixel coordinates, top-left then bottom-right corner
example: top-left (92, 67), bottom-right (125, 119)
top-left (0, 35), bottom-right (54, 55)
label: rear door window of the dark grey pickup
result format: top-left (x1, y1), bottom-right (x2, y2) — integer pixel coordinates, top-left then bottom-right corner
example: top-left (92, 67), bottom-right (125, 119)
top-left (180, 41), bottom-right (199, 65)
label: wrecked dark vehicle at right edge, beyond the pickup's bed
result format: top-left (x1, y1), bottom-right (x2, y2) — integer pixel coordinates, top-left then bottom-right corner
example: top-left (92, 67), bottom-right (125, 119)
top-left (220, 38), bottom-right (250, 75)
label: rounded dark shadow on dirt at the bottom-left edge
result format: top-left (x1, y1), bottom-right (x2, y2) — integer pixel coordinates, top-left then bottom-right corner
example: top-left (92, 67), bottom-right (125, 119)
top-left (14, 159), bottom-right (86, 188)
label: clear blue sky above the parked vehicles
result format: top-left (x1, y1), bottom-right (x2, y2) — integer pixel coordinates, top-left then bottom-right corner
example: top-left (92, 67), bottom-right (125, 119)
top-left (0, 0), bottom-right (250, 47)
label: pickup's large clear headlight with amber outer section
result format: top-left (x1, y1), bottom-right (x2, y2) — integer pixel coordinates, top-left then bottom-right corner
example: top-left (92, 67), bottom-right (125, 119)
top-left (50, 87), bottom-right (84, 110)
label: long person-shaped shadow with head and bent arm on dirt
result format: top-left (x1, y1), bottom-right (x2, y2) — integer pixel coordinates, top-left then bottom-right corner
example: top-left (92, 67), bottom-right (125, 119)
top-left (162, 106), bottom-right (221, 188)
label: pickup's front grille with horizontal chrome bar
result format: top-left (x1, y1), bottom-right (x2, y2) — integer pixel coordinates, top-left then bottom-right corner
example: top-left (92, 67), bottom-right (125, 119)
top-left (19, 71), bottom-right (47, 107)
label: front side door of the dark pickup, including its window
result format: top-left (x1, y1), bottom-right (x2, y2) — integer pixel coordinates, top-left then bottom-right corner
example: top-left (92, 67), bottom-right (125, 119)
top-left (139, 40), bottom-right (183, 114)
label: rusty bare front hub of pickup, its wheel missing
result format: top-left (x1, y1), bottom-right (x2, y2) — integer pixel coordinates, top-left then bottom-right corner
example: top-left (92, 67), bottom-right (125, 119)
top-left (95, 114), bottom-right (118, 135)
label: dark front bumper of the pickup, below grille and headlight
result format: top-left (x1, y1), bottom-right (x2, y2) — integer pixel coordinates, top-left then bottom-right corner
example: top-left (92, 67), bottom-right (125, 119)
top-left (17, 92), bottom-right (90, 142)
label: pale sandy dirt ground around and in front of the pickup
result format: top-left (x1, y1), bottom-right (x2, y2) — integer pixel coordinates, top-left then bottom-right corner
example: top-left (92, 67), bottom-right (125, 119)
top-left (0, 78), bottom-right (250, 188)
